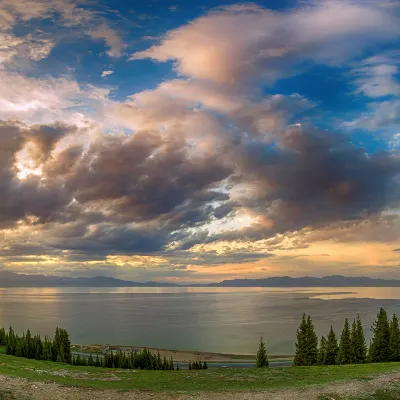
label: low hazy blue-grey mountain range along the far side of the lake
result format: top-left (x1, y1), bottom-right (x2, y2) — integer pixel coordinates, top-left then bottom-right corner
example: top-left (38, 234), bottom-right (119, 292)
top-left (0, 271), bottom-right (400, 287)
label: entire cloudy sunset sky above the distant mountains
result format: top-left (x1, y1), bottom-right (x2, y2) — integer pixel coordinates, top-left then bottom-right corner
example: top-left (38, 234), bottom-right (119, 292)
top-left (0, 0), bottom-right (400, 283)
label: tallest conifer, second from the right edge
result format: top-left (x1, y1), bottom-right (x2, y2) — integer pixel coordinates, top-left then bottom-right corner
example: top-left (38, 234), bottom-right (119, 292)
top-left (369, 308), bottom-right (390, 362)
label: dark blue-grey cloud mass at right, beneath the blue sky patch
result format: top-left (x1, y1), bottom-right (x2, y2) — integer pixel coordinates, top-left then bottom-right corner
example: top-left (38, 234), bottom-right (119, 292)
top-left (227, 127), bottom-right (400, 238)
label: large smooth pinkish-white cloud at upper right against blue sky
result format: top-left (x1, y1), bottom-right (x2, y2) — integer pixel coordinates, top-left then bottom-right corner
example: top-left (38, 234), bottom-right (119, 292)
top-left (131, 0), bottom-right (400, 84)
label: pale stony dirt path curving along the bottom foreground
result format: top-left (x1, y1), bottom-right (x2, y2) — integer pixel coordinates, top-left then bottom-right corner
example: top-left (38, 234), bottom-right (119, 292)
top-left (0, 373), bottom-right (400, 400)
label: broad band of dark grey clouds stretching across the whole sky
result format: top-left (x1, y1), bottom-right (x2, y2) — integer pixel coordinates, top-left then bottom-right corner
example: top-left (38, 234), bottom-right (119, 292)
top-left (0, 114), bottom-right (400, 264)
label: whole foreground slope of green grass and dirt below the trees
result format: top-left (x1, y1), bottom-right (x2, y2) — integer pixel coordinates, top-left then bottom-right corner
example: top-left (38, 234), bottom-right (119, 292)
top-left (0, 354), bottom-right (400, 400)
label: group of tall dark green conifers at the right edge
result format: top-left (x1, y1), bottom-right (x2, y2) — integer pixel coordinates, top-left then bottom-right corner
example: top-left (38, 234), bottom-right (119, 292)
top-left (293, 308), bottom-right (400, 366)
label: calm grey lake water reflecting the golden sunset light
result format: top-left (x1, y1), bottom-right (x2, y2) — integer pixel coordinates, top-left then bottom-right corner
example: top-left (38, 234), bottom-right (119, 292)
top-left (0, 288), bottom-right (400, 354)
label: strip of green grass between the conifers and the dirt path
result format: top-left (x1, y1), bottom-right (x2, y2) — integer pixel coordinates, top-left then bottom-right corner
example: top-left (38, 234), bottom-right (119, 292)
top-left (0, 354), bottom-right (400, 394)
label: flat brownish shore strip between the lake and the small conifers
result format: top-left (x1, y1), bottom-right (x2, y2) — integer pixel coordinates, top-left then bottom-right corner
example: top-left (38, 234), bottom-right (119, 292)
top-left (71, 344), bottom-right (293, 363)
